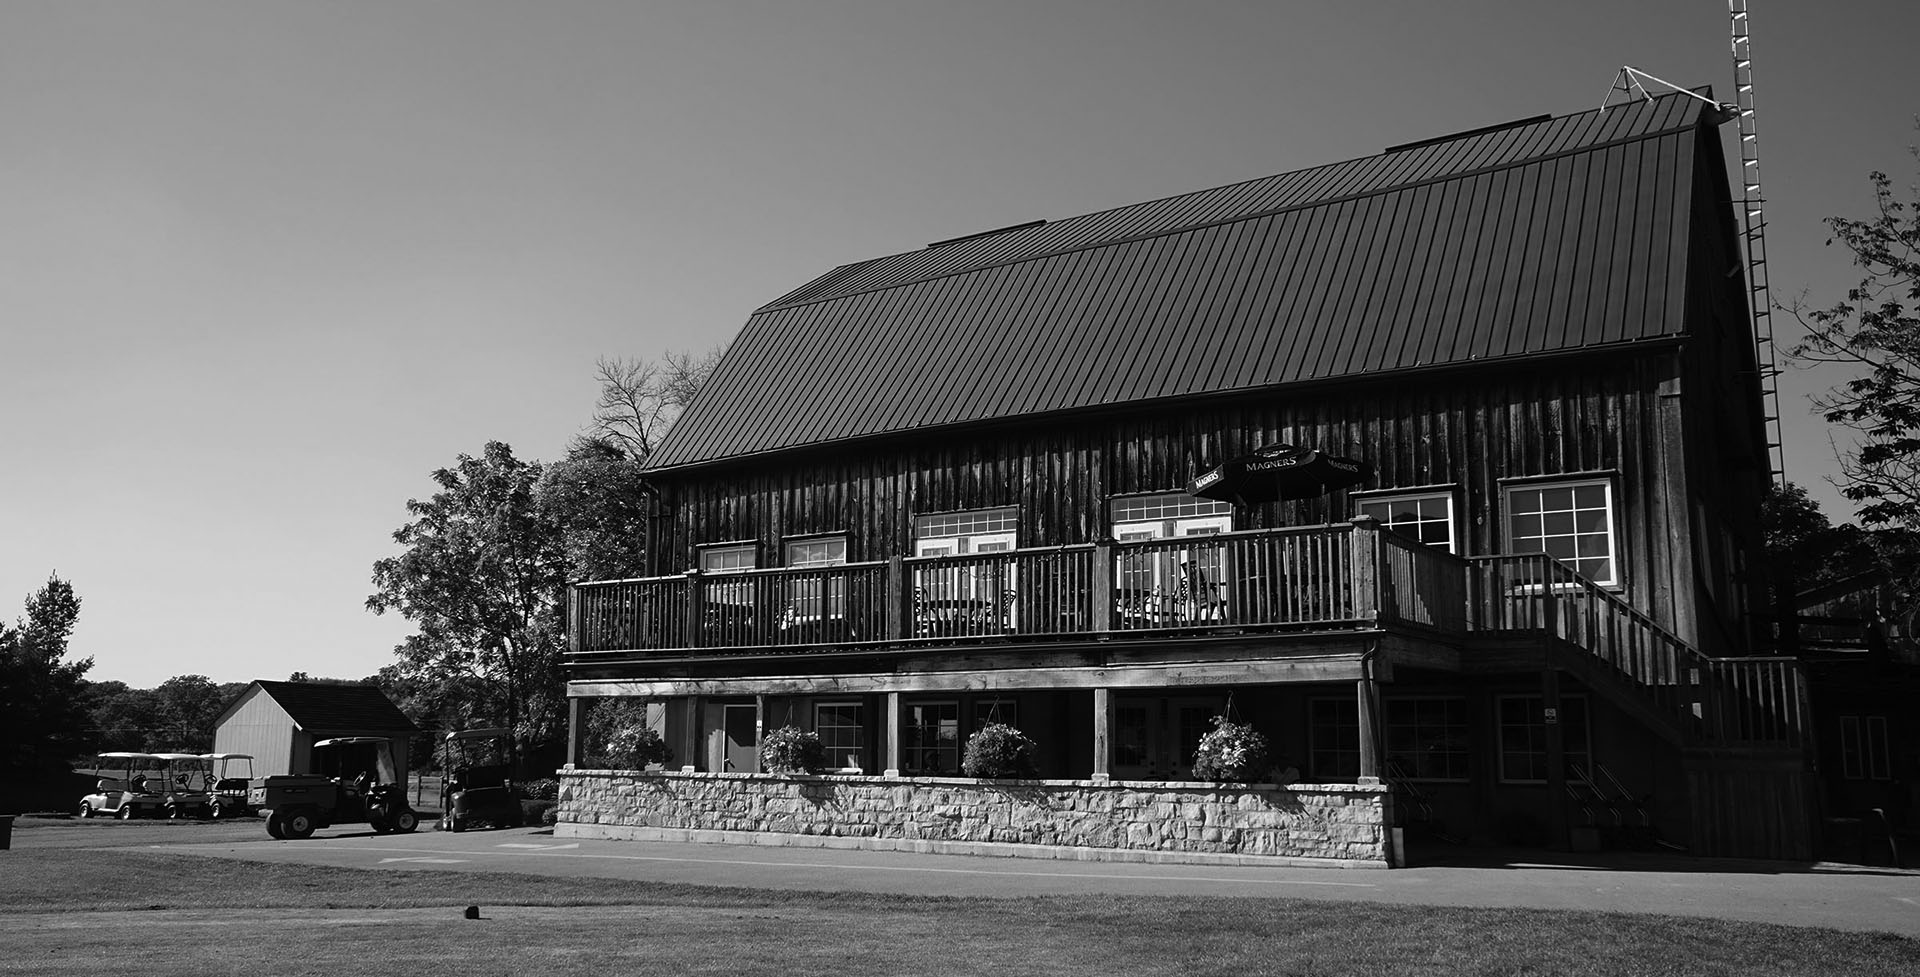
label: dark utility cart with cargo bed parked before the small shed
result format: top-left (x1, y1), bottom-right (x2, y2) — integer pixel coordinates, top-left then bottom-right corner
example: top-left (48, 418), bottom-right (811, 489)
top-left (248, 737), bottom-right (420, 841)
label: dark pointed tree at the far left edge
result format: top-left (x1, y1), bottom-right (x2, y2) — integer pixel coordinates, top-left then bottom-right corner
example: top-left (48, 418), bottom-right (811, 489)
top-left (0, 576), bottom-right (94, 777)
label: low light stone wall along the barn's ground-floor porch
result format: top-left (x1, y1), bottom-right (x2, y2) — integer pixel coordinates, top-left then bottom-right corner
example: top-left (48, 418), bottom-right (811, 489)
top-left (555, 770), bottom-right (1390, 868)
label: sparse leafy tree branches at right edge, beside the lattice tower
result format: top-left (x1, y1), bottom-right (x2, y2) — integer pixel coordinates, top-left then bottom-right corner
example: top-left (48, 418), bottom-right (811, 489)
top-left (1788, 142), bottom-right (1920, 530)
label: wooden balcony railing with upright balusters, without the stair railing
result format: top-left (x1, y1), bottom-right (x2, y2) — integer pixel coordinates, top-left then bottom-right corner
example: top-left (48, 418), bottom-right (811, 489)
top-left (570, 522), bottom-right (1467, 655)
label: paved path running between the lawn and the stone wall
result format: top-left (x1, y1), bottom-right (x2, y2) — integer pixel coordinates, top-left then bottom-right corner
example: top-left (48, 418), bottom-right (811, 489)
top-left (148, 829), bottom-right (1920, 937)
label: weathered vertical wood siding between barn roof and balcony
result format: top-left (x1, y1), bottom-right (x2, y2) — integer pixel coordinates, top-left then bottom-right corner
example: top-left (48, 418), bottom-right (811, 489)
top-left (653, 347), bottom-right (1720, 637)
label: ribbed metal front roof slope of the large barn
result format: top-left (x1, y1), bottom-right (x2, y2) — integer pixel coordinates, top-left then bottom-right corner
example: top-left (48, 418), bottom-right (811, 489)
top-left (653, 94), bottom-right (1703, 472)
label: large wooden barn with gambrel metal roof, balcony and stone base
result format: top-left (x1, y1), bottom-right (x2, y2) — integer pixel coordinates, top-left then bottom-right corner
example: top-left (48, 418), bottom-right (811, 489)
top-left (561, 94), bottom-right (1814, 866)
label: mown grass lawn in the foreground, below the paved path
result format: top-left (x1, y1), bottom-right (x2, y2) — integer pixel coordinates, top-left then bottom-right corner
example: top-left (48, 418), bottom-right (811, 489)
top-left (0, 825), bottom-right (1920, 977)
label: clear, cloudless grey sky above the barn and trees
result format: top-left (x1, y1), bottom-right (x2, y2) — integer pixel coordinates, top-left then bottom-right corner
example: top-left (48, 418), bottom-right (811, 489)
top-left (0, 0), bottom-right (1920, 685)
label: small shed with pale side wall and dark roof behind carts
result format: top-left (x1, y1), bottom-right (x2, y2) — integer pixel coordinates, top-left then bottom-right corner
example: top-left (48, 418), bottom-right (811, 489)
top-left (213, 681), bottom-right (420, 783)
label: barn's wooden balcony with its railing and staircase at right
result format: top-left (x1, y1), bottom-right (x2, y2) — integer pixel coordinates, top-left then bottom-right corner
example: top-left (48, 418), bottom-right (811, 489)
top-left (566, 520), bottom-right (1807, 747)
